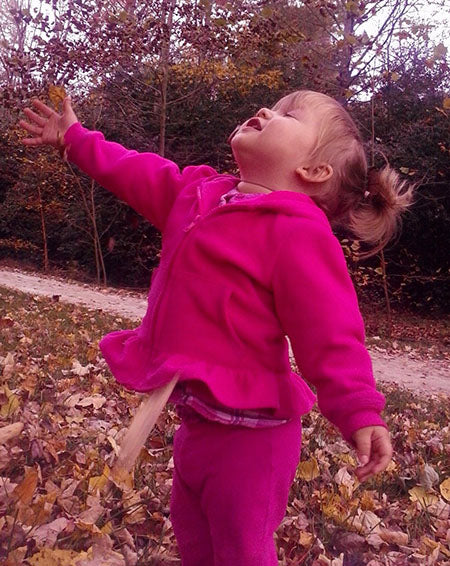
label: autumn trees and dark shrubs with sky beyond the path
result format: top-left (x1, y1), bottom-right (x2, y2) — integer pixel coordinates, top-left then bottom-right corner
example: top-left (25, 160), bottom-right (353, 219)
top-left (0, 0), bottom-right (450, 316)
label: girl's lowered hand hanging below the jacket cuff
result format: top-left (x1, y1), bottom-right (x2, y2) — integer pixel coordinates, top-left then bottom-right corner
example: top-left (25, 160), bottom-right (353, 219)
top-left (352, 426), bottom-right (393, 482)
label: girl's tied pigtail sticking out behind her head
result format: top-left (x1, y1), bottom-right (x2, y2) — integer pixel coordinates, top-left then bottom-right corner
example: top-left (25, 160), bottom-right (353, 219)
top-left (349, 165), bottom-right (415, 259)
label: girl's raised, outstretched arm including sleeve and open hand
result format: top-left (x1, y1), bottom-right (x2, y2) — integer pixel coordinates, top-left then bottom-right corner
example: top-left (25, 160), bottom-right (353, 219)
top-left (20, 98), bottom-right (215, 230)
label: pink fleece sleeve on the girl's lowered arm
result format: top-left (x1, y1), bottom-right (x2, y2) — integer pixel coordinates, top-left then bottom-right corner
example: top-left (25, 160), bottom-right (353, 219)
top-left (273, 220), bottom-right (388, 446)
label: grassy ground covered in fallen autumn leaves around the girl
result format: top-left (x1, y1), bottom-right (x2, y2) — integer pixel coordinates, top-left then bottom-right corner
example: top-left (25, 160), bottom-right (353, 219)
top-left (0, 288), bottom-right (450, 566)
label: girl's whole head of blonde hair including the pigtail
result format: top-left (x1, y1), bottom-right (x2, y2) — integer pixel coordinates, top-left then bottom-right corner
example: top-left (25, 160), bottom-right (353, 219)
top-left (273, 90), bottom-right (414, 259)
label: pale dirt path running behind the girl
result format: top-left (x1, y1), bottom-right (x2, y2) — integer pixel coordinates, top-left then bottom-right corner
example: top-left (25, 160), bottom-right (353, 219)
top-left (0, 269), bottom-right (450, 394)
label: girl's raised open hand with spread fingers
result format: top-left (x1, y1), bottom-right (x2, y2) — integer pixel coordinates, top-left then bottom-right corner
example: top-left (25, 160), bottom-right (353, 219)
top-left (19, 97), bottom-right (78, 149)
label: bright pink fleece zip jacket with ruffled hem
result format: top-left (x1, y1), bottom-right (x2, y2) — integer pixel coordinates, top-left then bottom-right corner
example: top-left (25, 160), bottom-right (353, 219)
top-left (65, 123), bottom-right (387, 444)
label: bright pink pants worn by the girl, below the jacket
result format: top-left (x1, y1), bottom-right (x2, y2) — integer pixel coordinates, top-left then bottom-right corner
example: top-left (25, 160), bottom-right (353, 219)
top-left (171, 416), bottom-right (302, 566)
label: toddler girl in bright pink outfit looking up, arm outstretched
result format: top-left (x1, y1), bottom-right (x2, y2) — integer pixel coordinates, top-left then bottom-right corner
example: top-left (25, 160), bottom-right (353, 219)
top-left (21, 91), bottom-right (411, 566)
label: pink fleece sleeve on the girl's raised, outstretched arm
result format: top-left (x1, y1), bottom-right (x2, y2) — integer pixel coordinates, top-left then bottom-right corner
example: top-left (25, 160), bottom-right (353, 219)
top-left (64, 122), bottom-right (215, 231)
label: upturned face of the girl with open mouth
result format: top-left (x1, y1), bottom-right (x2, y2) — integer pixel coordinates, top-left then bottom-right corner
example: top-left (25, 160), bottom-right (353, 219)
top-left (230, 102), bottom-right (320, 178)
